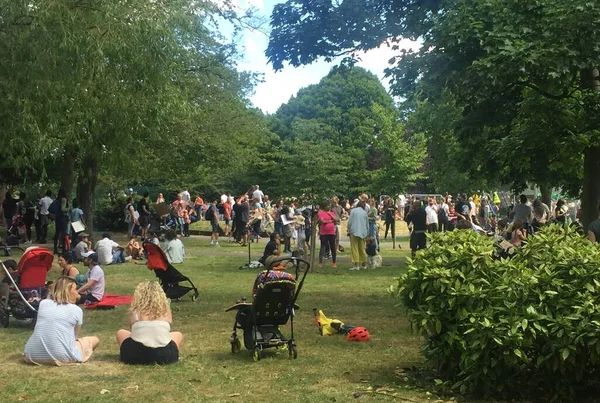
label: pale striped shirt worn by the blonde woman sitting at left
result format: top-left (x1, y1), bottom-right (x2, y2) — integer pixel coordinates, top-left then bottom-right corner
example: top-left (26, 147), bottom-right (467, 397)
top-left (23, 299), bottom-right (83, 364)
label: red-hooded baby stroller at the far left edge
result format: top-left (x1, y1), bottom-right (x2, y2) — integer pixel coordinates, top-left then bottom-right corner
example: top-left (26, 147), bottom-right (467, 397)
top-left (0, 248), bottom-right (54, 328)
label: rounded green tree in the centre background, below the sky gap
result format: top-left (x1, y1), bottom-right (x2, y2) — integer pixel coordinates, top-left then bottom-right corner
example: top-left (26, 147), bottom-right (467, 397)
top-left (272, 66), bottom-right (425, 195)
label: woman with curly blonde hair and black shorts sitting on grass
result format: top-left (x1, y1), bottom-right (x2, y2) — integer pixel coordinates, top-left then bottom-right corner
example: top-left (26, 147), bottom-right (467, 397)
top-left (117, 281), bottom-right (183, 365)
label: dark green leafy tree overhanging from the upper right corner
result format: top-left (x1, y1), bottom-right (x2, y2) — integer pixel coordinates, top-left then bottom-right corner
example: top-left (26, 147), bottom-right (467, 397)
top-left (267, 0), bottom-right (600, 227)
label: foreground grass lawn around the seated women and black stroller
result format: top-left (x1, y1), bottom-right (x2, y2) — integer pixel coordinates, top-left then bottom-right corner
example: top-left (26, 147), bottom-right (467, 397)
top-left (0, 229), bottom-right (436, 402)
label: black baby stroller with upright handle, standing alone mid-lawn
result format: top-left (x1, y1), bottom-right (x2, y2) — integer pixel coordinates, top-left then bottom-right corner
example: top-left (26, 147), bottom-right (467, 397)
top-left (226, 257), bottom-right (310, 361)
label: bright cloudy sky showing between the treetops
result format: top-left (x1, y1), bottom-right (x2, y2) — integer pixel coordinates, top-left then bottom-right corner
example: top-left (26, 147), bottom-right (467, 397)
top-left (223, 0), bottom-right (414, 113)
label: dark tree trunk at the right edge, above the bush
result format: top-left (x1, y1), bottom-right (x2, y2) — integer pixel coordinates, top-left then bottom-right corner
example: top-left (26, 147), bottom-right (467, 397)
top-left (581, 146), bottom-right (600, 230)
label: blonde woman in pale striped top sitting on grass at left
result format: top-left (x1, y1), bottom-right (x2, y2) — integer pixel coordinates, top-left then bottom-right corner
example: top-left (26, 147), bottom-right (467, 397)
top-left (23, 276), bottom-right (100, 366)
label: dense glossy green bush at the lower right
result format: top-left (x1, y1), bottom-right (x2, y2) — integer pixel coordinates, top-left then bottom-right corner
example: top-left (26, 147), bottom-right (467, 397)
top-left (396, 226), bottom-right (600, 398)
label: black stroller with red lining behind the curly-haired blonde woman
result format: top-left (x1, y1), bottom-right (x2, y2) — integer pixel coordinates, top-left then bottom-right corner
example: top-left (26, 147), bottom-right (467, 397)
top-left (142, 242), bottom-right (198, 302)
